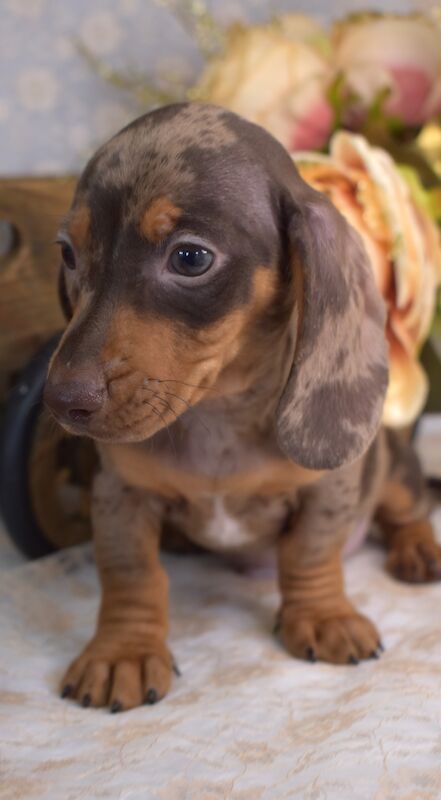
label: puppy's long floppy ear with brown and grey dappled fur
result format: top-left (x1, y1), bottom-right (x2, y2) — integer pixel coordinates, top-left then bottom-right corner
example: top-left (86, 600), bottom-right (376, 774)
top-left (276, 183), bottom-right (388, 469)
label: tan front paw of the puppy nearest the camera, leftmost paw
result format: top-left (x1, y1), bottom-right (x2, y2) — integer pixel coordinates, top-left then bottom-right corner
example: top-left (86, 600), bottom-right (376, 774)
top-left (61, 634), bottom-right (173, 713)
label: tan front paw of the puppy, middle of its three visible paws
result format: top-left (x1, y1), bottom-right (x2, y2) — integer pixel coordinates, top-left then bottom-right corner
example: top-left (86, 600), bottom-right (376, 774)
top-left (280, 603), bottom-right (383, 664)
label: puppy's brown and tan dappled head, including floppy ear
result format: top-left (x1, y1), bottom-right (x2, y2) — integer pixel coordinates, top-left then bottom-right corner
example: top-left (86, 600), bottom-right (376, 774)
top-left (45, 104), bottom-right (386, 468)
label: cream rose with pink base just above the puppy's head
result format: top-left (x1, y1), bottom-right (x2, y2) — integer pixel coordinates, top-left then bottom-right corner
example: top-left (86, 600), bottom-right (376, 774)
top-left (191, 21), bottom-right (333, 151)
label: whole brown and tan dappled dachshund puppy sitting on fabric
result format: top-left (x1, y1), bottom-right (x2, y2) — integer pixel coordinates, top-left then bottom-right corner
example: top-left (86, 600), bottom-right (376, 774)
top-left (45, 103), bottom-right (441, 711)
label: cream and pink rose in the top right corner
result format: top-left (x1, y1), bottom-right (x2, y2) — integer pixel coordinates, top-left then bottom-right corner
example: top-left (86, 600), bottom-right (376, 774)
top-left (332, 14), bottom-right (441, 125)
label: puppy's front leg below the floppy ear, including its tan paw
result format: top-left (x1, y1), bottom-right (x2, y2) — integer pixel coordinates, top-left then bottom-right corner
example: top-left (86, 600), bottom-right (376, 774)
top-left (278, 471), bottom-right (381, 664)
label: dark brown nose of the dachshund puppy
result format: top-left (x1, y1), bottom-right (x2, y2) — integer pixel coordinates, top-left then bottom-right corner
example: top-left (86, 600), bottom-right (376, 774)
top-left (44, 378), bottom-right (105, 426)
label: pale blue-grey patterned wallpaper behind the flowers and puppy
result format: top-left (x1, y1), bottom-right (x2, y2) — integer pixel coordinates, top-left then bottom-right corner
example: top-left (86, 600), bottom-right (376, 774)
top-left (0, 0), bottom-right (422, 174)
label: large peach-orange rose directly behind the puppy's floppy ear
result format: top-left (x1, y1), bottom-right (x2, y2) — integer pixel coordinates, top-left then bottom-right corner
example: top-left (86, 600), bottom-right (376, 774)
top-left (295, 131), bottom-right (441, 427)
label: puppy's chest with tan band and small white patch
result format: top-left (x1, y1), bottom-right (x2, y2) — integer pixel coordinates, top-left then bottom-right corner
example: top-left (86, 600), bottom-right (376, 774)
top-left (106, 406), bottom-right (314, 551)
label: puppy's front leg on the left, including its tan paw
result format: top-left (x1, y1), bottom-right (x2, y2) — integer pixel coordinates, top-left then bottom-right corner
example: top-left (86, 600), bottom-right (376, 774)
top-left (62, 472), bottom-right (172, 711)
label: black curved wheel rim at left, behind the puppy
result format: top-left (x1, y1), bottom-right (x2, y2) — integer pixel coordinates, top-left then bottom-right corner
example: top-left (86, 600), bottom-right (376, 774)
top-left (0, 334), bottom-right (60, 558)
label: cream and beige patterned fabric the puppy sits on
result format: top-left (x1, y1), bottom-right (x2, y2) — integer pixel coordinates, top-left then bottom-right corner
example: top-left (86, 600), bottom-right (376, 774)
top-left (0, 422), bottom-right (441, 800)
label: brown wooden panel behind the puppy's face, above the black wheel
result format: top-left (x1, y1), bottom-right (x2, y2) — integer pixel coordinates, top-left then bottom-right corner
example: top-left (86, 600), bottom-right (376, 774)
top-left (0, 177), bottom-right (75, 400)
